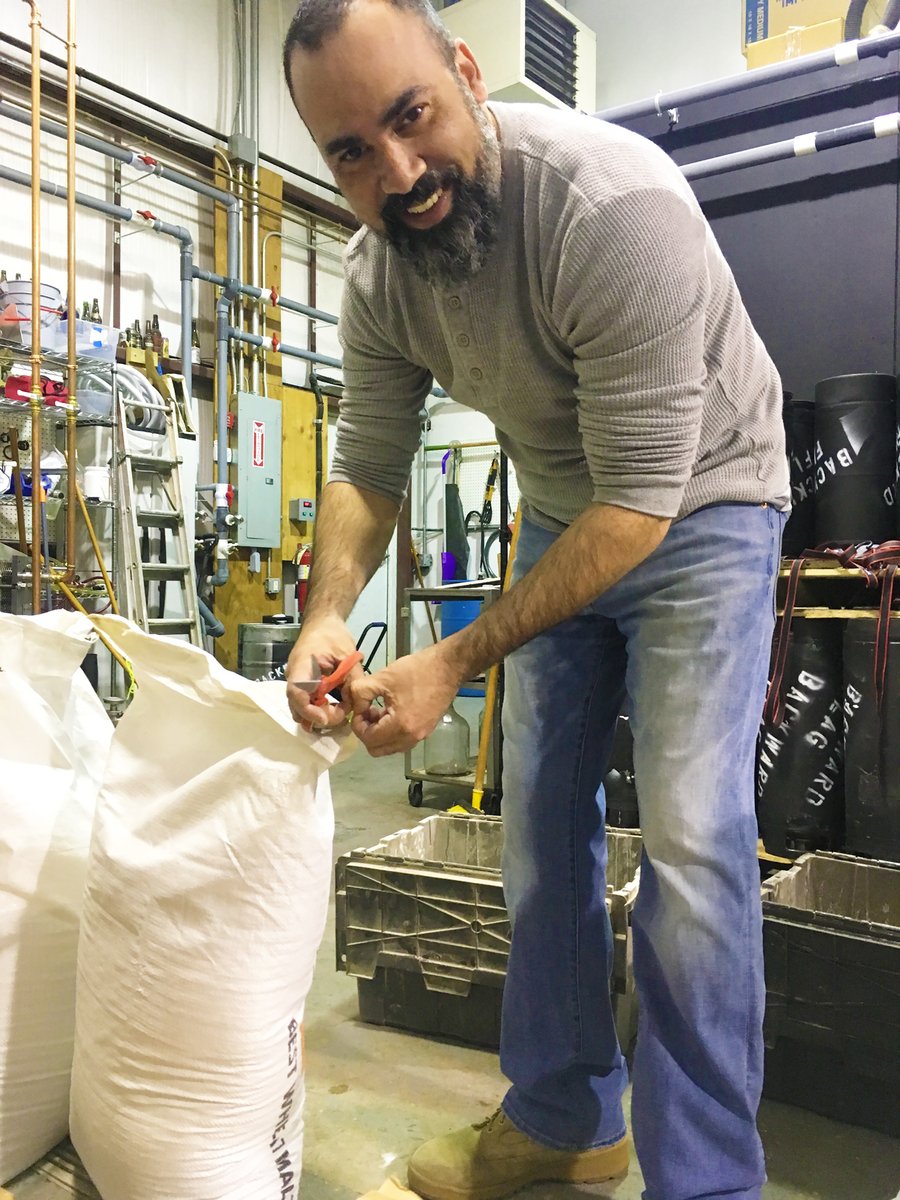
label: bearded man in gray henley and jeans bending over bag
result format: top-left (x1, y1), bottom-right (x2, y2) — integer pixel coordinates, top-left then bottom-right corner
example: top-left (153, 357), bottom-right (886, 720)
top-left (284, 0), bottom-right (788, 1200)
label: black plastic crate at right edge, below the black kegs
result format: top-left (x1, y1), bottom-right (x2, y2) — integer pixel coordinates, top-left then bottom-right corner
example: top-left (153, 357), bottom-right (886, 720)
top-left (763, 853), bottom-right (900, 1134)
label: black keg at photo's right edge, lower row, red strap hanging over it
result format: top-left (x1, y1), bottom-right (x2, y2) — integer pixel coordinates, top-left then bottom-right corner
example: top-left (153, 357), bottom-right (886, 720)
top-left (844, 613), bottom-right (900, 862)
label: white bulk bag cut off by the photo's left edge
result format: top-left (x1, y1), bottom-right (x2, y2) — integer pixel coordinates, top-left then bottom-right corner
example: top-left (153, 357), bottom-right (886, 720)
top-left (0, 612), bottom-right (113, 1183)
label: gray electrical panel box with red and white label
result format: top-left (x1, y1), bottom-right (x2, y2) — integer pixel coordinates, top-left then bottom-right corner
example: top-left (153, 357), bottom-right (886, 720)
top-left (235, 391), bottom-right (282, 550)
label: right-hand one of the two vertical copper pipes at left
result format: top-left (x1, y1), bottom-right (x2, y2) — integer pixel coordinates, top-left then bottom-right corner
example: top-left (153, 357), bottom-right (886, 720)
top-left (62, 0), bottom-right (78, 583)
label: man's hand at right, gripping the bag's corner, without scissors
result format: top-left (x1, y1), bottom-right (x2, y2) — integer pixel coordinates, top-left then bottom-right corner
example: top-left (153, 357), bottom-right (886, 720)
top-left (344, 642), bottom-right (463, 758)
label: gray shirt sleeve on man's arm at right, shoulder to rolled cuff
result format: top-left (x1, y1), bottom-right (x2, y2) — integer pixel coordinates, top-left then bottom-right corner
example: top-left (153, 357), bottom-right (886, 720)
top-left (553, 187), bottom-right (710, 517)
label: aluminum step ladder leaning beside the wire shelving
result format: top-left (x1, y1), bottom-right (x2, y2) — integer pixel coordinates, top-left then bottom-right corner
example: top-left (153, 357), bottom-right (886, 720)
top-left (116, 391), bottom-right (204, 647)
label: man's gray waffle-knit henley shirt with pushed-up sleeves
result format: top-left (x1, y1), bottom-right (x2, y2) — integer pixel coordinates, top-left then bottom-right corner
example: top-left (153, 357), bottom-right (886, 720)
top-left (329, 103), bottom-right (790, 530)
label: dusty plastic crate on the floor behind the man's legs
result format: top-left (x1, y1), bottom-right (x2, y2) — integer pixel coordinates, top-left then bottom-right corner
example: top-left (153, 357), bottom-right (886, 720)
top-left (335, 814), bottom-right (642, 1046)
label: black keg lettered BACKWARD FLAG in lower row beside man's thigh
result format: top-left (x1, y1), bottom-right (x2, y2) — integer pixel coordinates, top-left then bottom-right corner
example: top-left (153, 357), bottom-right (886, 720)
top-left (756, 617), bottom-right (844, 856)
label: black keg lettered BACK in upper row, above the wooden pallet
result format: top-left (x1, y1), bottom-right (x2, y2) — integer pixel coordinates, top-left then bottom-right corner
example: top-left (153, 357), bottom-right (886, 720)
top-left (816, 374), bottom-right (896, 545)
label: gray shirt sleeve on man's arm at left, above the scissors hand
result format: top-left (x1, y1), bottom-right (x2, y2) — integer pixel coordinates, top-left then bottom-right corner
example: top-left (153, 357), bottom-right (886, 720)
top-left (329, 281), bottom-right (432, 503)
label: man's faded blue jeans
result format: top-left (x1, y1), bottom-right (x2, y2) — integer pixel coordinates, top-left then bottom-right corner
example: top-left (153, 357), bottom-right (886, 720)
top-left (500, 504), bottom-right (785, 1200)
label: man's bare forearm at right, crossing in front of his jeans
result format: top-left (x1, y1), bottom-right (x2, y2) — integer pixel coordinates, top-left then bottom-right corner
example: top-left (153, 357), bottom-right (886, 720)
top-left (446, 504), bottom-right (671, 679)
